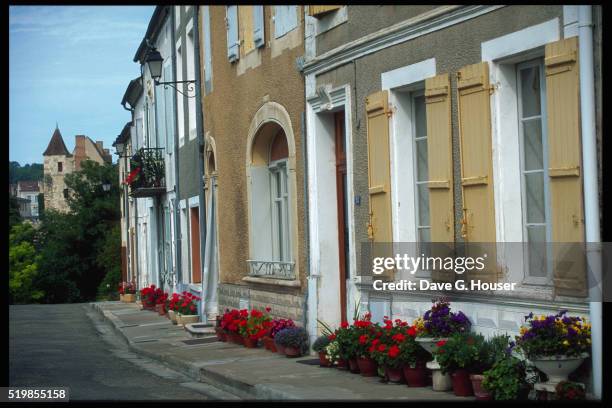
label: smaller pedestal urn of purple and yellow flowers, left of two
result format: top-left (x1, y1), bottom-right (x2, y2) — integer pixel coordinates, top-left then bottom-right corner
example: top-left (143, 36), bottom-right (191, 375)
top-left (413, 297), bottom-right (471, 391)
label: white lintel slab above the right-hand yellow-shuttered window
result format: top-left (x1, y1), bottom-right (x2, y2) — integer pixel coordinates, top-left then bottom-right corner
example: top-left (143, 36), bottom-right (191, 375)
top-left (481, 18), bottom-right (559, 61)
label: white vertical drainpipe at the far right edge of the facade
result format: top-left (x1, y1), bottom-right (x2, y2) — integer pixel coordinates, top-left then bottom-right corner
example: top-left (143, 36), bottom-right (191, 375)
top-left (578, 6), bottom-right (603, 399)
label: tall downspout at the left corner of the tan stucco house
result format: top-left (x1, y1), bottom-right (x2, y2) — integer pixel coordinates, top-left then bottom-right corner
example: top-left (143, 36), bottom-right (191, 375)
top-left (193, 5), bottom-right (207, 323)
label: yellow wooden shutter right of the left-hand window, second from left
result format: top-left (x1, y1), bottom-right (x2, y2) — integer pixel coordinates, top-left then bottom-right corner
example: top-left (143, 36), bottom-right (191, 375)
top-left (425, 74), bottom-right (455, 282)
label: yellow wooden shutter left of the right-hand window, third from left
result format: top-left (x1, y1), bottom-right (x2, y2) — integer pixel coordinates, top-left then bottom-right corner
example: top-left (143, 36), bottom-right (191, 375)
top-left (457, 62), bottom-right (497, 282)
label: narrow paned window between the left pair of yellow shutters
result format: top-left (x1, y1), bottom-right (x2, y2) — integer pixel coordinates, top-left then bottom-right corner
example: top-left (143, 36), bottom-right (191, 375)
top-left (412, 91), bottom-right (431, 242)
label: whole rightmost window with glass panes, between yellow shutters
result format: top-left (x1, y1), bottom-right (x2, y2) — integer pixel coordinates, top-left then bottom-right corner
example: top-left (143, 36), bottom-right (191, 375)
top-left (516, 59), bottom-right (551, 284)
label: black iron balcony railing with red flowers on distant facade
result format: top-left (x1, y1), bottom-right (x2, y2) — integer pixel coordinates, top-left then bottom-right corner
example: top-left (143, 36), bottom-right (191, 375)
top-left (126, 147), bottom-right (166, 197)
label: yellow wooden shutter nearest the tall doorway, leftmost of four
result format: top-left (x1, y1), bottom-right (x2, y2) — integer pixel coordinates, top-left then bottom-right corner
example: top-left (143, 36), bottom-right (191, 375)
top-left (366, 91), bottom-right (394, 280)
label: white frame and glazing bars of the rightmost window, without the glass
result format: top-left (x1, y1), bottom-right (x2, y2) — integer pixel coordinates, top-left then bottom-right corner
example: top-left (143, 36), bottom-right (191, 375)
top-left (515, 58), bottom-right (552, 285)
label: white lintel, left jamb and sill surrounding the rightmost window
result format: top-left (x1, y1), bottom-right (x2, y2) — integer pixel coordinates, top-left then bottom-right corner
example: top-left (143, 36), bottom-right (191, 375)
top-left (481, 18), bottom-right (561, 290)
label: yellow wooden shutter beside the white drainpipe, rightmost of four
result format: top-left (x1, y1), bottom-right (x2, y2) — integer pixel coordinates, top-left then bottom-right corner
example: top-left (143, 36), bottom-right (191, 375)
top-left (544, 37), bottom-right (587, 296)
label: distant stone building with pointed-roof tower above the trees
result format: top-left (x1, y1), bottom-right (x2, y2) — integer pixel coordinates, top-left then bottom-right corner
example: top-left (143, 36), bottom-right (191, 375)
top-left (43, 127), bottom-right (112, 212)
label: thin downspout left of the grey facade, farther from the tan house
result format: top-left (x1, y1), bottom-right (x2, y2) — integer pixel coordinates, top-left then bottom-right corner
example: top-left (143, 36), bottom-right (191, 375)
top-left (170, 6), bottom-right (183, 290)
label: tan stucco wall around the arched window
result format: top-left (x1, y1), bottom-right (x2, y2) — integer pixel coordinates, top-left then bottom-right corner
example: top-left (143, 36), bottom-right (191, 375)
top-left (200, 6), bottom-right (306, 295)
